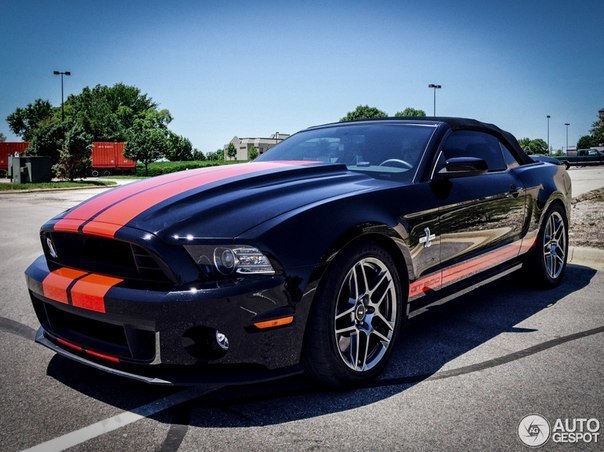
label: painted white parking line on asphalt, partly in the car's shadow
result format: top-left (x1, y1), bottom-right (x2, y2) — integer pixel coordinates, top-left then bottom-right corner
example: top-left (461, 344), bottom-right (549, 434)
top-left (24, 385), bottom-right (220, 452)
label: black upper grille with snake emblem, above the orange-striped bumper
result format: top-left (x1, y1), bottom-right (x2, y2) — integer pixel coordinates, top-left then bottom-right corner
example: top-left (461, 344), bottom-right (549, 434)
top-left (42, 232), bottom-right (171, 285)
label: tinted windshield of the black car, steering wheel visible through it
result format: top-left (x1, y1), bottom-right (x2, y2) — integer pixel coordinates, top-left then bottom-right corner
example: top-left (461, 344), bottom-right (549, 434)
top-left (256, 123), bottom-right (436, 181)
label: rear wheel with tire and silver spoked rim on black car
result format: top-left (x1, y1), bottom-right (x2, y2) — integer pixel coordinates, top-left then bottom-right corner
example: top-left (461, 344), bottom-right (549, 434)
top-left (526, 204), bottom-right (568, 288)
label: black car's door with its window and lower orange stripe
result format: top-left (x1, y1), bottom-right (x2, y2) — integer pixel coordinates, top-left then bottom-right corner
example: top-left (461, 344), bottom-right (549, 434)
top-left (434, 131), bottom-right (525, 287)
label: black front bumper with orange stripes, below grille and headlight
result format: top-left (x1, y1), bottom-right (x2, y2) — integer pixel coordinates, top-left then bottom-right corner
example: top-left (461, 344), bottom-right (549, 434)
top-left (26, 256), bottom-right (313, 384)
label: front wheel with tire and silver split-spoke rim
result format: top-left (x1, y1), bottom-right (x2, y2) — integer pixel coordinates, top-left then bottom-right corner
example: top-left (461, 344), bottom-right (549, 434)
top-left (302, 243), bottom-right (407, 386)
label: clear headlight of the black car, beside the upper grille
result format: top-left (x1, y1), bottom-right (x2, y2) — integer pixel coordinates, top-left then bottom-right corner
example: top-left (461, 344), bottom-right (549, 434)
top-left (185, 245), bottom-right (275, 276)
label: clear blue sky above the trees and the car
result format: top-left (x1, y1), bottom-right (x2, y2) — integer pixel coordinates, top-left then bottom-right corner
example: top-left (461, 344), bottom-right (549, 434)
top-left (0, 0), bottom-right (604, 152)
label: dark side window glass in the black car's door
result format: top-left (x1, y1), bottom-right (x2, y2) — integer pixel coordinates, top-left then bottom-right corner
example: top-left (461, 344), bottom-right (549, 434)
top-left (442, 131), bottom-right (508, 171)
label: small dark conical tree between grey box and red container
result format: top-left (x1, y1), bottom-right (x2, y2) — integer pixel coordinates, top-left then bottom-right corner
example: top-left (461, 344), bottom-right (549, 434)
top-left (53, 124), bottom-right (92, 181)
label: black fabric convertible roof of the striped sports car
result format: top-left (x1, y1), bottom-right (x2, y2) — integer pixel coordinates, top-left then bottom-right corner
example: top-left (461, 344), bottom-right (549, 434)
top-left (310, 116), bottom-right (535, 164)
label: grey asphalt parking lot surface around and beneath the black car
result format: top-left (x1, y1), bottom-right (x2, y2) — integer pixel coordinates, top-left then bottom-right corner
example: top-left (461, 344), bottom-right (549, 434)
top-left (0, 168), bottom-right (604, 451)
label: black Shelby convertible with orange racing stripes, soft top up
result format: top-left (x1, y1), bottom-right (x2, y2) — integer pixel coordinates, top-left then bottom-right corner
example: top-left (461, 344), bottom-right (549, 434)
top-left (26, 118), bottom-right (571, 385)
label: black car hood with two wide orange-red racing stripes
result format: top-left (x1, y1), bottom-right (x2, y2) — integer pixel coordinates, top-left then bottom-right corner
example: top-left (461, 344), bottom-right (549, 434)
top-left (54, 161), bottom-right (378, 242)
